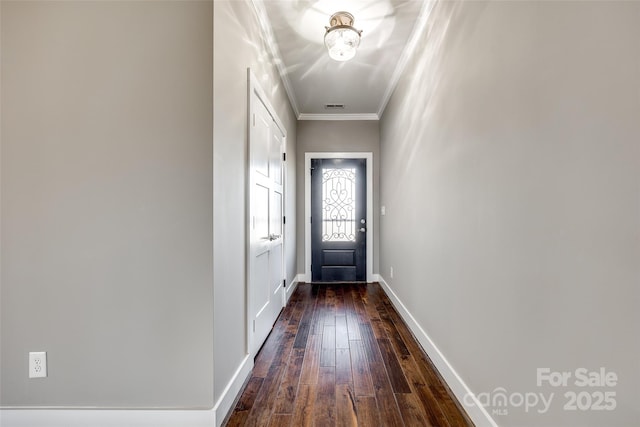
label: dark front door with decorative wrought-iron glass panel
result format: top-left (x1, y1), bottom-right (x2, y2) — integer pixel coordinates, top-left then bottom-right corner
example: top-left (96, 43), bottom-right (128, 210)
top-left (311, 159), bottom-right (367, 282)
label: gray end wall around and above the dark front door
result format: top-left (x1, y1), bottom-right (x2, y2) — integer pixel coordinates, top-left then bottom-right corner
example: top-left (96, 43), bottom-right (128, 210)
top-left (296, 120), bottom-right (380, 274)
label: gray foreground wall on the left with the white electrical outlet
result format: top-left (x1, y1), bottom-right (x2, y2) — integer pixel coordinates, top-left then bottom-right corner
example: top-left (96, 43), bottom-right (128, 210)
top-left (0, 1), bottom-right (213, 407)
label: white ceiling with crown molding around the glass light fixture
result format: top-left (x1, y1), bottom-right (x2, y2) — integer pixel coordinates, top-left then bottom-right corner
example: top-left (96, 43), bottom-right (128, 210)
top-left (253, 0), bottom-right (431, 120)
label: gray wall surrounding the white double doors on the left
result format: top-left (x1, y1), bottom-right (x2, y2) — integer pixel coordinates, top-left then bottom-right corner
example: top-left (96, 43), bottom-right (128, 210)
top-left (213, 0), bottom-right (296, 406)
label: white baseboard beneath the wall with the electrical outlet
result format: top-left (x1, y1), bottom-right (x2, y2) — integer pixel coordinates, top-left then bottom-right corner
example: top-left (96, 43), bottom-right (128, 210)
top-left (0, 408), bottom-right (216, 427)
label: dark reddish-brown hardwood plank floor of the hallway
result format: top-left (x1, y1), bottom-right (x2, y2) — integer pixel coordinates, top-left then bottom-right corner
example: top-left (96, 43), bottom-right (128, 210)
top-left (226, 283), bottom-right (473, 427)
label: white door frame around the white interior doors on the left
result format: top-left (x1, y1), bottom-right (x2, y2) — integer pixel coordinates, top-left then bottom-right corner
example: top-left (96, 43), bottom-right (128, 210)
top-left (245, 68), bottom-right (287, 359)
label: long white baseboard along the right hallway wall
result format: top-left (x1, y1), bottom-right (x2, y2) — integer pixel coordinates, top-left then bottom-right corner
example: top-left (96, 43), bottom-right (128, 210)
top-left (377, 275), bottom-right (498, 427)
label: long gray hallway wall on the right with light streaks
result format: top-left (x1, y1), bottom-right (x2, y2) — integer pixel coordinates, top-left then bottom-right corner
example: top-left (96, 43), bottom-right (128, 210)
top-left (380, 2), bottom-right (640, 427)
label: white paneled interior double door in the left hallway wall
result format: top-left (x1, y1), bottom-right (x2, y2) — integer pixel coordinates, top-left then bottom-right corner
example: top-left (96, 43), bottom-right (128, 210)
top-left (248, 86), bottom-right (284, 355)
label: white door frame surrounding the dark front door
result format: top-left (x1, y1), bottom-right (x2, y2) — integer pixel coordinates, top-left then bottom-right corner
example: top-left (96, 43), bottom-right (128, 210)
top-left (304, 152), bottom-right (373, 283)
